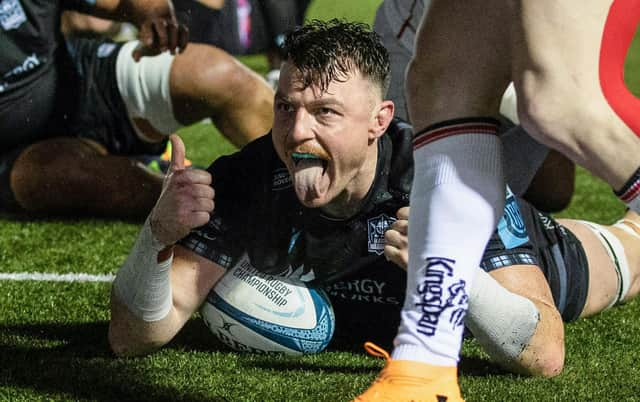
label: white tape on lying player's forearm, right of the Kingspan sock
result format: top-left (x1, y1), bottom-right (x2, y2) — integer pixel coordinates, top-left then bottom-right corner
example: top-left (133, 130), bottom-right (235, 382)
top-left (465, 268), bottom-right (540, 363)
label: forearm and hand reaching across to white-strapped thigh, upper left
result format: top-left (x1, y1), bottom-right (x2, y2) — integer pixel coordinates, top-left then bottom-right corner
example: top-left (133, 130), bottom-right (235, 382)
top-left (91, 0), bottom-right (189, 60)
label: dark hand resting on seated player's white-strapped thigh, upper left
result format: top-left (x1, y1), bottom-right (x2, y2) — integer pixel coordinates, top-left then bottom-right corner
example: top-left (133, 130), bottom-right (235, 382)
top-left (132, 6), bottom-right (189, 61)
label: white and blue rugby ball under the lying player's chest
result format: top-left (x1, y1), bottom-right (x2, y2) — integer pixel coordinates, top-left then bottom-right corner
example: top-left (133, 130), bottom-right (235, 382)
top-left (200, 258), bottom-right (335, 355)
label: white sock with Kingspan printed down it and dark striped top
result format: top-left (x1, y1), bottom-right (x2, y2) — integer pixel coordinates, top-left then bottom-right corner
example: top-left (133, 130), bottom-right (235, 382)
top-left (392, 121), bottom-right (505, 366)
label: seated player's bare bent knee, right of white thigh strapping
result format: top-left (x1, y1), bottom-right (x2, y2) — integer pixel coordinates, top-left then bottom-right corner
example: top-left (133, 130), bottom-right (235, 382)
top-left (170, 43), bottom-right (273, 146)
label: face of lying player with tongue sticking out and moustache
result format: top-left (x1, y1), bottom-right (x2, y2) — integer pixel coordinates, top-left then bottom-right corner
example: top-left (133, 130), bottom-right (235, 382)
top-left (272, 63), bottom-right (393, 216)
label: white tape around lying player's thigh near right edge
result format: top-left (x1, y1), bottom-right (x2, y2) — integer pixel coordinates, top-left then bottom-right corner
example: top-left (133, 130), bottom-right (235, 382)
top-left (578, 221), bottom-right (631, 308)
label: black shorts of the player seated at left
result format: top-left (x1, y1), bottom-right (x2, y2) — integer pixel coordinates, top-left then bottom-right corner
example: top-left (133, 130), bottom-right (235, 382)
top-left (0, 38), bottom-right (166, 210)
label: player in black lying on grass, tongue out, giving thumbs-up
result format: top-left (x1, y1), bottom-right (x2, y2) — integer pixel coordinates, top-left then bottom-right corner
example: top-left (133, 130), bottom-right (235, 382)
top-left (109, 21), bottom-right (638, 390)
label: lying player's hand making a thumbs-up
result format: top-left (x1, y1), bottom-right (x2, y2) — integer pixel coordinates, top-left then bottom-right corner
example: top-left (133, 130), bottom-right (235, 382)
top-left (151, 134), bottom-right (215, 246)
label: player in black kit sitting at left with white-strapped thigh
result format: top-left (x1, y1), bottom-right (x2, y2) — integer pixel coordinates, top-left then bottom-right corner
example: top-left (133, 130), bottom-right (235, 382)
top-left (0, 0), bottom-right (273, 218)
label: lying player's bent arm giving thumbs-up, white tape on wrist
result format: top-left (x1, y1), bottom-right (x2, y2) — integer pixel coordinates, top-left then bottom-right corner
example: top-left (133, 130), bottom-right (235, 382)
top-left (109, 135), bottom-right (215, 355)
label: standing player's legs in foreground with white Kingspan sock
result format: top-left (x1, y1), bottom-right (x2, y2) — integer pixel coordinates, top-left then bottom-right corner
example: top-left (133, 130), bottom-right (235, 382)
top-left (367, 0), bottom-right (640, 400)
